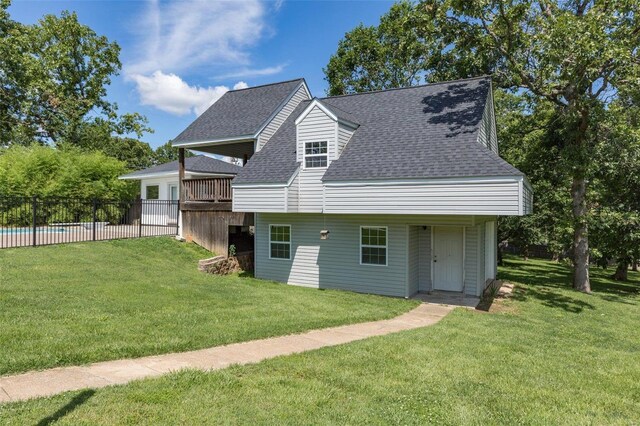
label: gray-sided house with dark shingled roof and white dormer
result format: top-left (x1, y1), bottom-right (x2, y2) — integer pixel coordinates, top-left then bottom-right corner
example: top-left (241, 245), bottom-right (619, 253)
top-left (174, 77), bottom-right (533, 297)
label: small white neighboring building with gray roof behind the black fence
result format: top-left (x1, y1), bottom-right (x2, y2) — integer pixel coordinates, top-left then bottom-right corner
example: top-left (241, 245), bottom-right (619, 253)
top-left (120, 155), bottom-right (242, 236)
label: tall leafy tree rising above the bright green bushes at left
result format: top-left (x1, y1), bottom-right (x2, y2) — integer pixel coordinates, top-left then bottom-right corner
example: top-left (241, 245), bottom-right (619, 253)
top-left (0, 0), bottom-right (151, 145)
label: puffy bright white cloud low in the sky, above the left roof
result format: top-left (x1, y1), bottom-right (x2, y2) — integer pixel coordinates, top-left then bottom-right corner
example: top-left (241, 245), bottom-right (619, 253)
top-left (129, 71), bottom-right (249, 115)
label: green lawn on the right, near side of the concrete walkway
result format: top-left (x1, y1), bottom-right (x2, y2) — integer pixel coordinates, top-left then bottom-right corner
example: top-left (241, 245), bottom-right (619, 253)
top-left (0, 259), bottom-right (640, 425)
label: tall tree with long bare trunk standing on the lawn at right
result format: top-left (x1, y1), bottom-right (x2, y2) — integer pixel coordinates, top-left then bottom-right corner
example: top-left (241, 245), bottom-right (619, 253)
top-left (421, 0), bottom-right (640, 292)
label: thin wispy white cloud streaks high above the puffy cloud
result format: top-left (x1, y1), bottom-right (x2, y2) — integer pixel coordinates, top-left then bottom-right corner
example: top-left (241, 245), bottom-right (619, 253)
top-left (126, 0), bottom-right (266, 75)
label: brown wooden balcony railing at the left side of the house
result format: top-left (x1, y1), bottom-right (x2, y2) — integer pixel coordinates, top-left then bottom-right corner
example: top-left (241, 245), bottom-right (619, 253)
top-left (182, 178), bottom-right (233, 210)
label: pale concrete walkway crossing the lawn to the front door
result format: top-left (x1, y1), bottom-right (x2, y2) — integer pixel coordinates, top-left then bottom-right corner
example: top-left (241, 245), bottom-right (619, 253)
top-left (0, 303), bottom-right (454, 403)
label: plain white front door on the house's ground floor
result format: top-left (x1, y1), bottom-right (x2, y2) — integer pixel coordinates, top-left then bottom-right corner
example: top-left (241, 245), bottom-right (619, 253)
top-left (433, 226), bottom-right (463, 291)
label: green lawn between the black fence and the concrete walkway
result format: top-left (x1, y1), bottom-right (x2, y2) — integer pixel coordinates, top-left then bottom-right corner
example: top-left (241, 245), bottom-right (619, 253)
top-left (0, 238), bottom-right (416, 375)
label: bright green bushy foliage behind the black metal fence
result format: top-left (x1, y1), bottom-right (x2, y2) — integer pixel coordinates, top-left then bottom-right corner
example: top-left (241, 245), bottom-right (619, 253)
top-left (0, 146), bottom-right (136, 199)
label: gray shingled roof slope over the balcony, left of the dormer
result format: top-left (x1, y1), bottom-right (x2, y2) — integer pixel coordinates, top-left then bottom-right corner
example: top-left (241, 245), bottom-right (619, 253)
top-left (172, 78), bottom-right (304, 144)
